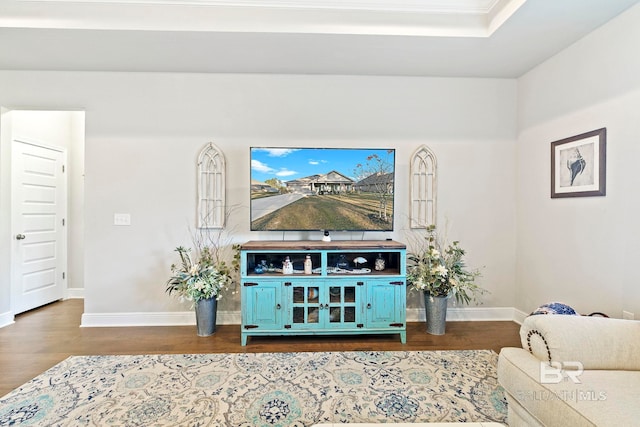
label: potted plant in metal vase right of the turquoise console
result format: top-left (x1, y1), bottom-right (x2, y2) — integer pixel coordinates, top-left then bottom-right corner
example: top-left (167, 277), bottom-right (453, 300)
top-left (407, 225), bottom-right (486, 335)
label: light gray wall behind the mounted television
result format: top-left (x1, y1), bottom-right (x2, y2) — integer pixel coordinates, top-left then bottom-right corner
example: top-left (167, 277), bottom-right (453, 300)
top-left (0, 71), bottom-right (517, 324)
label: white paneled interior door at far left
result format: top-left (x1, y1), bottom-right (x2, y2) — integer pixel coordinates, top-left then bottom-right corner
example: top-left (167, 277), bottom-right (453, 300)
top-left (11, 140), bottom-right (67, 314)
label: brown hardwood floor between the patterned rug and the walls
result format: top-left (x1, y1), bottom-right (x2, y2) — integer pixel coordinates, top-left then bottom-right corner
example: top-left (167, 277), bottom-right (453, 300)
top-left (0, 299), bottom-right (520, 396)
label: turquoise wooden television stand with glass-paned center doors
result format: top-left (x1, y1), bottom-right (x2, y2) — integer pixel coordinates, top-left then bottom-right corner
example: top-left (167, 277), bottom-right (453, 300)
top-left (240, 240), bottom-right (407, 346)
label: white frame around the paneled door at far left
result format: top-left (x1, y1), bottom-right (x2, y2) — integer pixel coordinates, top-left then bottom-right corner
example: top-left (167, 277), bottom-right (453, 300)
top-left (10, 135), bottom-right (69, 315)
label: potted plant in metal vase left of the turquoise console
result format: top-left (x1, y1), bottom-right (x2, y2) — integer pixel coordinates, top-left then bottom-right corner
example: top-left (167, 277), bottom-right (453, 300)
top-left (166, 245), bottom-right (239, 336)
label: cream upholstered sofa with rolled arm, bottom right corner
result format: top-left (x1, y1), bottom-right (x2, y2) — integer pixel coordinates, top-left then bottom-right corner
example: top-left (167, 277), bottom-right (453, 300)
top-left (498, 315), bottom-right (640, 427)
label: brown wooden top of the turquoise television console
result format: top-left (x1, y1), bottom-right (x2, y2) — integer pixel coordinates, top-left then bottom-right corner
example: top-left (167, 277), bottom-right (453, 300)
top-left (241, 240), bottom-right (407, 251)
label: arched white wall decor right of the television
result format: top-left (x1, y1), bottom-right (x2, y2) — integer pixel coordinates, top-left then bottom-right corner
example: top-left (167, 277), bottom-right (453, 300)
top-left (410, 145), bottom-right (437, 228)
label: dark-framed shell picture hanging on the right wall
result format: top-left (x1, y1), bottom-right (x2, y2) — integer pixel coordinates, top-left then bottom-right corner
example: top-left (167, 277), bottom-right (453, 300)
top-left (551, 128), bottom-right (607, 199)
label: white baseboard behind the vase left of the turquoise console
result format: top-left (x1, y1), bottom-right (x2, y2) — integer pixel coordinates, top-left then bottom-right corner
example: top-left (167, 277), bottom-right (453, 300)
top-left (80, 311), bottom-right (240, 328)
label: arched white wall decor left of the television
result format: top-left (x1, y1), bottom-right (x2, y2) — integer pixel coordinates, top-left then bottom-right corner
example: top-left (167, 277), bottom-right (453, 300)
top-left (197, 142), bottom-right (226, 228)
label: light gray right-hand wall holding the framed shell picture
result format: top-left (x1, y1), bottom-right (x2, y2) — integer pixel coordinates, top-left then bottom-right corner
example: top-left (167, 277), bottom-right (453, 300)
top-left (516, 2), bottom-right (640, 317)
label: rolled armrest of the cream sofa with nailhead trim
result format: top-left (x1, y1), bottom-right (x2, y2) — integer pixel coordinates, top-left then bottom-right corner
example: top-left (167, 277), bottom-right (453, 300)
top-left (520, 315), bottom-right (640, 371)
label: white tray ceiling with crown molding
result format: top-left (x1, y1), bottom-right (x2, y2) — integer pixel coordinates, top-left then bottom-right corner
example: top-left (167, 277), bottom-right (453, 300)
top-left (0, 0), bottom-right (640, 77)
